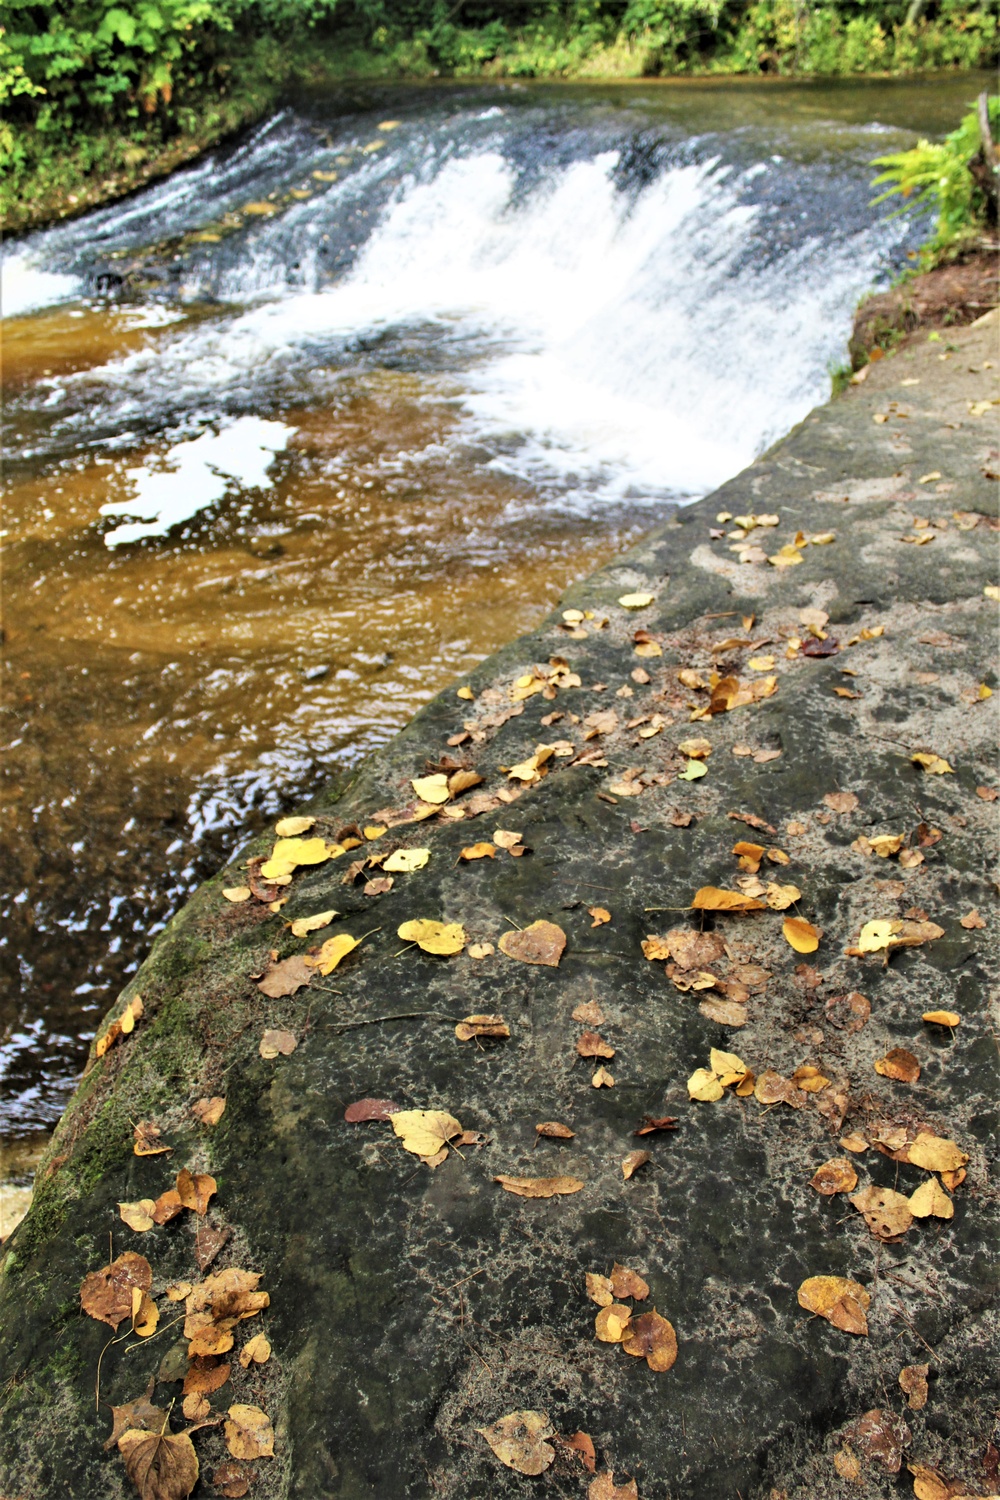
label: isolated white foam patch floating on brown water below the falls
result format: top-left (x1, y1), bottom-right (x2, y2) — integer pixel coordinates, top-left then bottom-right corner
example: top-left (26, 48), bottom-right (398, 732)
top-left (100, 417), bottom-right (295, 548)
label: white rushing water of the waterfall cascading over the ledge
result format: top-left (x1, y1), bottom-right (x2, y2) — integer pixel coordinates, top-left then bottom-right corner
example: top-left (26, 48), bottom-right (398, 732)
top-left (5, 135), bottom-right (904, 540)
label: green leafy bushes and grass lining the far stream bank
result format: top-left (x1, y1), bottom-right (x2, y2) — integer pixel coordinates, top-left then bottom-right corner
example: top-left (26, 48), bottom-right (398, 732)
top-left (0, 0), bottom-right (999, 230)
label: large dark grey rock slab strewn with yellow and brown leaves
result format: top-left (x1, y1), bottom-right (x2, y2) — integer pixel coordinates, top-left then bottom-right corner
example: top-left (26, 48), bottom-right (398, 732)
top-left (0, 314), bottom-right (1000, 1500)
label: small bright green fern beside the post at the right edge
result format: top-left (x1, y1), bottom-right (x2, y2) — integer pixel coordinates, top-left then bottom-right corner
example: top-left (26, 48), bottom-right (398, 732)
top-left (873, 96), bottom-right (1000, 270)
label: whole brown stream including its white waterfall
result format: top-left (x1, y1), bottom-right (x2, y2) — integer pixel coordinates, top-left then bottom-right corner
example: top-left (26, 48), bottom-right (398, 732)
top-left (0, 77), bottom-right (979, 1164)
